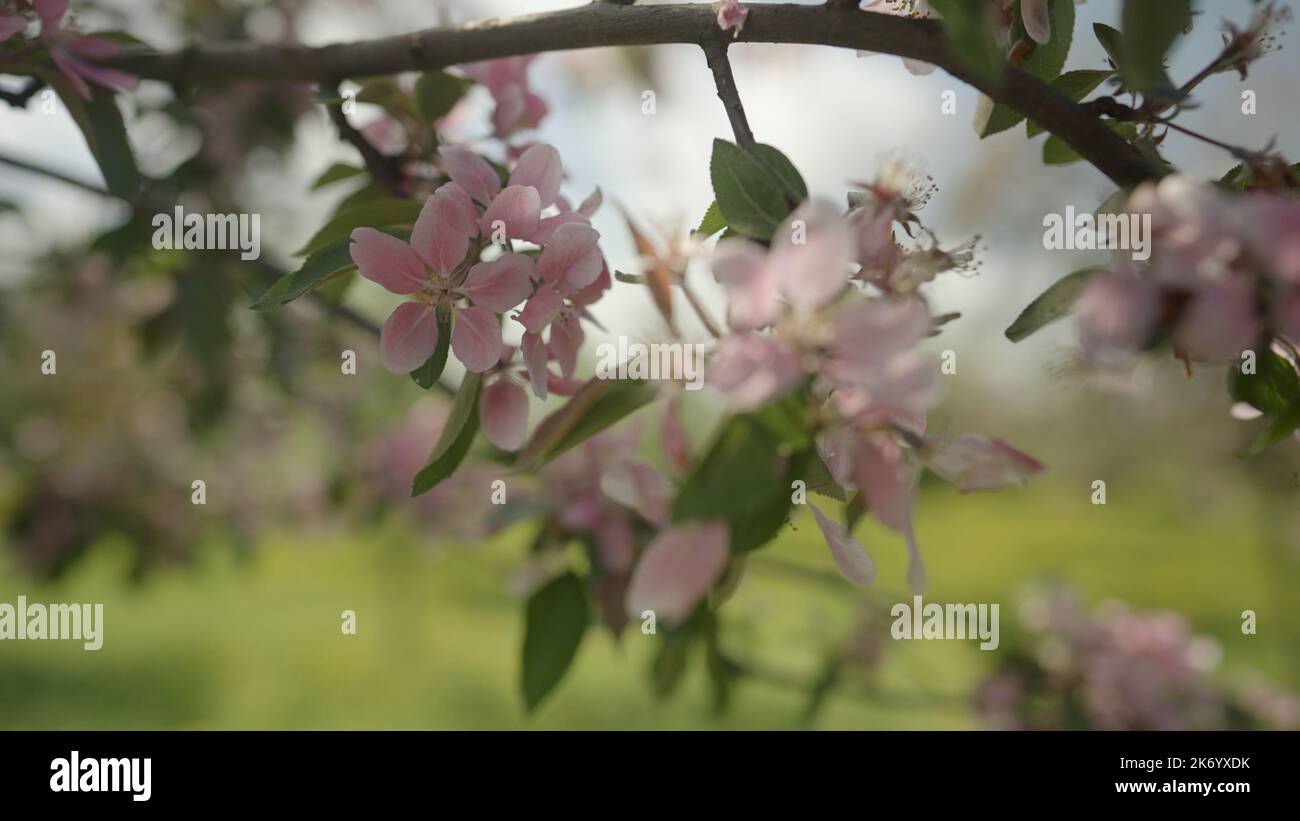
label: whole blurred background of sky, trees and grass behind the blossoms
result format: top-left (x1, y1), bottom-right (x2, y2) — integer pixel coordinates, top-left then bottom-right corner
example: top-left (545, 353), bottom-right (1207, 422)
top-left (0, 0), bottom-right (1300, 729)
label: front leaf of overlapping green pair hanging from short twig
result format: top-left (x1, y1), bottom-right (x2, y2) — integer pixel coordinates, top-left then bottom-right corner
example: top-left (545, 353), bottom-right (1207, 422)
top-left (709, 139), bottom-right (790, 242)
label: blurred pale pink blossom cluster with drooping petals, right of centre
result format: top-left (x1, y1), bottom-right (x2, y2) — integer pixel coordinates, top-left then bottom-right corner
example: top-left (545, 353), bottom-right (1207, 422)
top-left (707, 164), bottom-right (1043, 588)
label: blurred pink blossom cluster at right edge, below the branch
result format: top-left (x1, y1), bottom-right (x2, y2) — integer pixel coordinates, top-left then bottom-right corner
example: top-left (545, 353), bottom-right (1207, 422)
top-left (1075, 175), bottom-right (1300, 362)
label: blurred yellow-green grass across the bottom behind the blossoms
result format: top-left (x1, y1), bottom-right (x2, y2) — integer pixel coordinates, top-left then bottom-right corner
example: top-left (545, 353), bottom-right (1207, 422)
top-left (0, 475), bottom-right (1300, 729)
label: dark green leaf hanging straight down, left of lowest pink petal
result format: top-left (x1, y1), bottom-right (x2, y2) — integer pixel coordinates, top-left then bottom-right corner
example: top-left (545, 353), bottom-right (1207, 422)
top-left (521, 573), bottom-right (590, 712)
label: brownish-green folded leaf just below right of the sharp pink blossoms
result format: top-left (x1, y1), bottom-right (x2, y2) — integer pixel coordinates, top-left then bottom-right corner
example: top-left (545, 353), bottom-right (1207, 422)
top-left (515, 378), bottom-right (657, 470)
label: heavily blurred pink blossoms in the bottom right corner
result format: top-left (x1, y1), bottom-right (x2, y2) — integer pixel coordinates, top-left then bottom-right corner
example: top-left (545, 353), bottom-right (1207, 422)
top-left (976, 588), bottom-right (1300, 730)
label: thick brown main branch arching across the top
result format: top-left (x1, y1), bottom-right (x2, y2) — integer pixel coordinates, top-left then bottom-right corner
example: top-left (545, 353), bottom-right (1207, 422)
top-left (100, 3), bottom-right (1165, 184)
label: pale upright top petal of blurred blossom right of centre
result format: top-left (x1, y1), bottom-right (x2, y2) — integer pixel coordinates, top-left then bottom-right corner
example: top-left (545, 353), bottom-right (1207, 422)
top-left (768, 203), bottom-right (853, 314)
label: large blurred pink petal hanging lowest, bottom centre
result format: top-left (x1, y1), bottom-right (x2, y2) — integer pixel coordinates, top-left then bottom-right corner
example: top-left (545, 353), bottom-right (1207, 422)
top-left (627, 521), bottom-right (729, 626)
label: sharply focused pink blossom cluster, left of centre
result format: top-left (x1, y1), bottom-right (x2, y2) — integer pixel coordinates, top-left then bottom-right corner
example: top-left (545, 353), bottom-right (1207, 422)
top-left (351, 143), bottom-right (611, 449)
